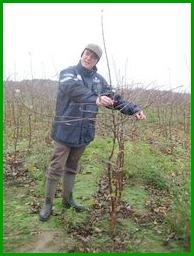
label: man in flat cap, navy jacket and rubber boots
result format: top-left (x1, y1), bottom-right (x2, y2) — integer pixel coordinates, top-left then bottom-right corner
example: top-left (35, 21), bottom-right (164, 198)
top-left (39, 44), bottom-right (145, 221)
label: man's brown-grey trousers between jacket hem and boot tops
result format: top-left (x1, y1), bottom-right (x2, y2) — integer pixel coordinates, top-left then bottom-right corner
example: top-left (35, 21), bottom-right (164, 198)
top-left (46, 142), bottom-right (86, 181)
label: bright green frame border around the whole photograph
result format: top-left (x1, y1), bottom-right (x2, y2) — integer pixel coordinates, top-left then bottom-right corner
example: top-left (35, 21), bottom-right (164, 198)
top-left (0, 0), bottom-right (194, 256)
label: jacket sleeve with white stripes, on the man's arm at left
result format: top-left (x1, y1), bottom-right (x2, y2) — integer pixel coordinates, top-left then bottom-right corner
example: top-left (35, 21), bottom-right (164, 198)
top-left (59, 69), bottom-right (98, 103)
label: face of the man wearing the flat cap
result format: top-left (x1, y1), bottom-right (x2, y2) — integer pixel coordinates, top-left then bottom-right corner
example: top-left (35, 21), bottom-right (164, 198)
top-left (81, 49), bottom-right (98, 70)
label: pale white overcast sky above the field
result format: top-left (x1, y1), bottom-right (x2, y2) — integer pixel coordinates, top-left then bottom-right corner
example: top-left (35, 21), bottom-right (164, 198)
top-left (3, 3), bottom-right (191, 92)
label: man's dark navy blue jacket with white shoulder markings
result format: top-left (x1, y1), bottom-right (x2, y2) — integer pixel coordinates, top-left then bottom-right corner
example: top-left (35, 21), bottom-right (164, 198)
top-left (51, 62), bottom-right (140, 147)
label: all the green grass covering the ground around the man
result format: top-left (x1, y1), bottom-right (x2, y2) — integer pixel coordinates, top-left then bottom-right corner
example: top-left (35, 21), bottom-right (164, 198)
top-left (4, 137), bottom-right (190, 252)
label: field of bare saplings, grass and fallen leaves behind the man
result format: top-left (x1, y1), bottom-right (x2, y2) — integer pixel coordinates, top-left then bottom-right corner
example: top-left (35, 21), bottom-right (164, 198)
top-left (3, 80), bottom-right (191, 253)
